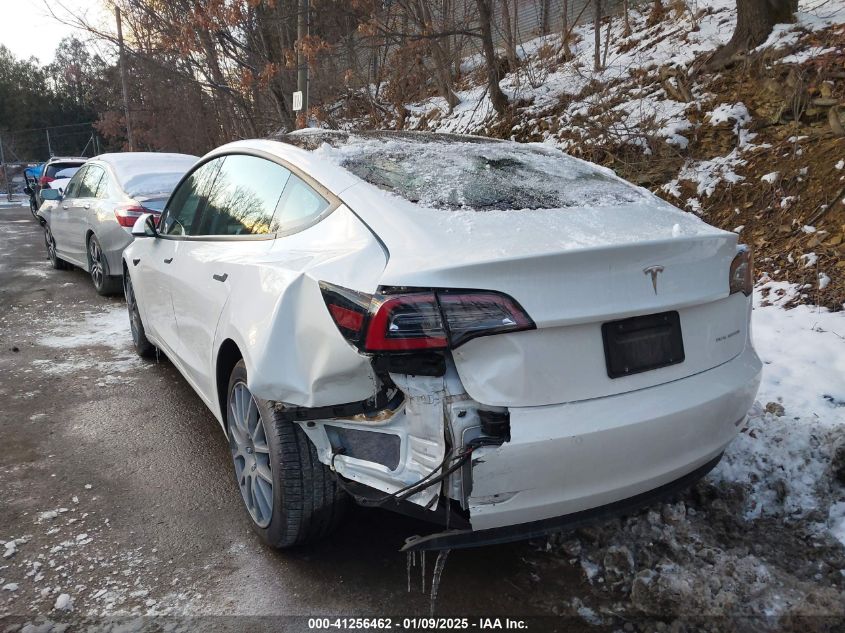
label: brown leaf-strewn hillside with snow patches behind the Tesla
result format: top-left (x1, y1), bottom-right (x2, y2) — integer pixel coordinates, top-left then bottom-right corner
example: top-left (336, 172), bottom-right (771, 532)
top-left (334, 0), bottom-right (845, 310)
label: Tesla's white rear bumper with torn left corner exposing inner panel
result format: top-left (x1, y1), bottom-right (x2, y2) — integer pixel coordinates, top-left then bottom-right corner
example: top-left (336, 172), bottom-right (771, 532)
top-left (301, 345), bottom-right (762, 550)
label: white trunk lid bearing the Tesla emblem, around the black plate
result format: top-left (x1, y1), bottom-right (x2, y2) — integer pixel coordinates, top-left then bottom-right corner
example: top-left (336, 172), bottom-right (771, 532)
top-left (344, 188), bottom-right (748, 406)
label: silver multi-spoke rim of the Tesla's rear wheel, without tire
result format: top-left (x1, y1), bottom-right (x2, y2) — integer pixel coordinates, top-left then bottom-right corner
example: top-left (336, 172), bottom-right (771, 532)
top-left (229, 382), bottom-right (273, 528)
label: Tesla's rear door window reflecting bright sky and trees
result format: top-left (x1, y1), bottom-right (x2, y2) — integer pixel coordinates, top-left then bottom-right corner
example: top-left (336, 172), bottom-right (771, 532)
top-left (198, 154), bottom-right (292, 235)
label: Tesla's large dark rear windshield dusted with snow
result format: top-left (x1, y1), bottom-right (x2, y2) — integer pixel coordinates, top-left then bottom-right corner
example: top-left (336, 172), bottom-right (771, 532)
top-left (290, 134), bottom-right (644, 211)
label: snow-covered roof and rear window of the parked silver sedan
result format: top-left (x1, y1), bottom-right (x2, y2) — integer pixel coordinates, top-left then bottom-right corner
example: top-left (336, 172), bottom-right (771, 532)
top-left (96, 152), bottom-right (199, 197)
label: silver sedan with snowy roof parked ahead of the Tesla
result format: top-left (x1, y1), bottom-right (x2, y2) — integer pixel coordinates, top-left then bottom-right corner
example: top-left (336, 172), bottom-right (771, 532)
top-left (38, 152), bottom-right (197, 294)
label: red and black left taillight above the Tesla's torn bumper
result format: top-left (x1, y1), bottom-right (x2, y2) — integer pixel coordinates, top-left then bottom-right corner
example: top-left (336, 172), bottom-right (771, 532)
top-left (320, 283), bottom-right (535, 353)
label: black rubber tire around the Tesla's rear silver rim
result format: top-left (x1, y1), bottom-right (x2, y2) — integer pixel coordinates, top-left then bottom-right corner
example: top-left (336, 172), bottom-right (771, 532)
top-left (226, 361), bottom-right (349, 549)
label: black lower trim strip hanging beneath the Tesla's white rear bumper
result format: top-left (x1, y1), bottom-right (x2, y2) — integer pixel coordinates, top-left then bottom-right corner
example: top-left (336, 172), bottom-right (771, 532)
top-left (402, 453), bottom-right (722, 552)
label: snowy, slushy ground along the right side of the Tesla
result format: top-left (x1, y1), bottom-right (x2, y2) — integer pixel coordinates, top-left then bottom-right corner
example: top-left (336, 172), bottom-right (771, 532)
top-left (545, 278), bottom-right (845, 631)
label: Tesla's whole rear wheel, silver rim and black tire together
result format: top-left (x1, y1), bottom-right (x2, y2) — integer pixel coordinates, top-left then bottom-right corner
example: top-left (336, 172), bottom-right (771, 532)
top-left (226, 361), bottom-right (348, 548)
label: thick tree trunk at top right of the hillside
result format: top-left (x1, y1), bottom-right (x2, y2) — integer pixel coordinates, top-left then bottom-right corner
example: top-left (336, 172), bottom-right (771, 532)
top-left (709, 0), bottom-right (798, 67)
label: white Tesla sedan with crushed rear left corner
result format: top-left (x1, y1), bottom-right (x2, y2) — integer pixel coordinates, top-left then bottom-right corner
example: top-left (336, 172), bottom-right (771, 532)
top-left (123, 131), bottom-right (761, 549)
